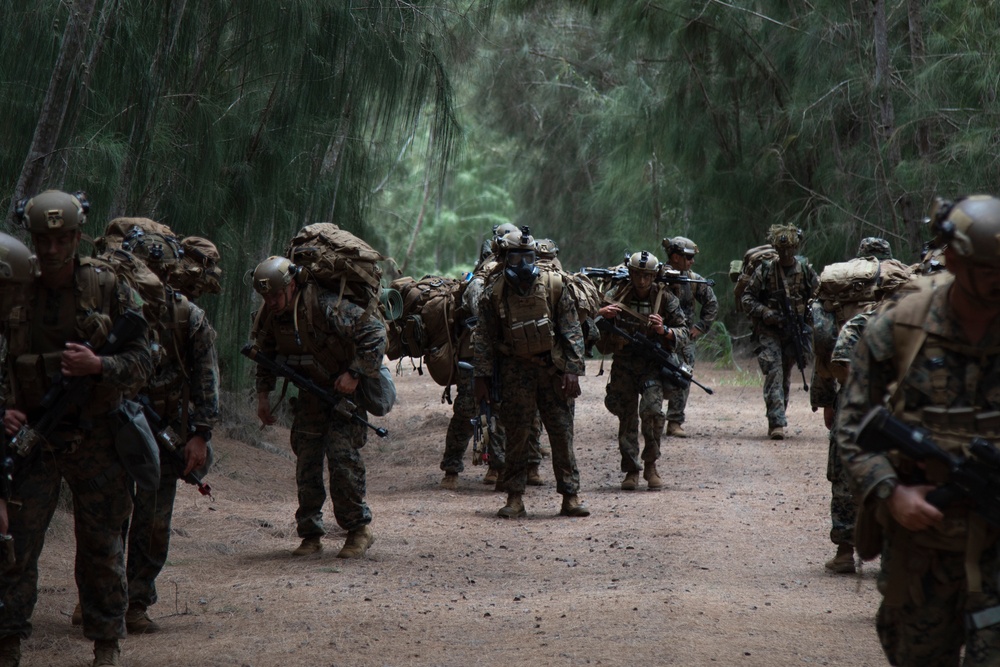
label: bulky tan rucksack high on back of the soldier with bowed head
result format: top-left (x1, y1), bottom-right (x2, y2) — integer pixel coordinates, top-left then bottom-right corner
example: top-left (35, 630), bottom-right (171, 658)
top-left (285, 222), bottom-right (388, 316)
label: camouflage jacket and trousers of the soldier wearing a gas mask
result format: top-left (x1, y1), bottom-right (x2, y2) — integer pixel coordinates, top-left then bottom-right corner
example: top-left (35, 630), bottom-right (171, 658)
top-left (472, 271), bottom-right (585, 496)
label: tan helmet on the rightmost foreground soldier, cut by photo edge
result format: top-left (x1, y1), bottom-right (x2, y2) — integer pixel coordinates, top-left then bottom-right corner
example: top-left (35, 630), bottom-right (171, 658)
top-left (928, 195), bottom-right (1000, 266)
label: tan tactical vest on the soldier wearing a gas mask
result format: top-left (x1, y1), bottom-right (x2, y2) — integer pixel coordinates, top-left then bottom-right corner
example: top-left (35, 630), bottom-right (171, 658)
top-left (491, 272), bottom-right (562, 359)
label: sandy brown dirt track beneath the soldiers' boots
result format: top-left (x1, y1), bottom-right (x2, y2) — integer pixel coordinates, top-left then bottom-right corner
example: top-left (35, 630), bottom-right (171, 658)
top-left (22, 362), bottom-right (885, 667)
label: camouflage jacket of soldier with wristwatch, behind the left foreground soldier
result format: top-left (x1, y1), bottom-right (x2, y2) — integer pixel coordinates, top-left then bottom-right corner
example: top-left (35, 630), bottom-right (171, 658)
top-left (147, 293), bottom-right (219, 436)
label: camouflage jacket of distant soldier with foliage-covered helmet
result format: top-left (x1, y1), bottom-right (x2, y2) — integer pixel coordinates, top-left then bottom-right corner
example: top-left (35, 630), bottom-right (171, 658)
top-left (740, 257), bottom-right (819, 338)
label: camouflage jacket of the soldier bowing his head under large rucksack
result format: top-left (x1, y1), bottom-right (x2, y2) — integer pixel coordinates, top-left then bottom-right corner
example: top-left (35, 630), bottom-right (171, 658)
top-left (256, 286), bottom-right (386, 393)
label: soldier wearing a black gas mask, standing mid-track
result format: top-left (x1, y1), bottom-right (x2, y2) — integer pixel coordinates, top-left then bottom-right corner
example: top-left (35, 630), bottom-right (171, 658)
top-left (473, 227), bottom-right (590, 518)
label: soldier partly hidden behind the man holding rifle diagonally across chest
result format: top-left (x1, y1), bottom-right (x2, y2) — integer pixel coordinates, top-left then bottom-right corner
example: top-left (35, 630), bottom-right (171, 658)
top-left (663, 236), bottom-right (719, 438)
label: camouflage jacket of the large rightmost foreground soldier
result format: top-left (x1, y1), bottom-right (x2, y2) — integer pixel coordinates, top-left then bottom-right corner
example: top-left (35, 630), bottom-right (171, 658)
top-left (836, 287), bottom-right (1000, 506)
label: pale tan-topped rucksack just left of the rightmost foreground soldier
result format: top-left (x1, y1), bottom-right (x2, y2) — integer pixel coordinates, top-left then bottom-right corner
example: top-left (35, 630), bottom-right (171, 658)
top-left (816, 257), bottom-right (910, 330)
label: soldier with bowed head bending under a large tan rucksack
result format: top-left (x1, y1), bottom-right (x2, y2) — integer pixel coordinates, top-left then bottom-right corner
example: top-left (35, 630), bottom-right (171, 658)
top-left (253, 257), bottom-right (386, 558)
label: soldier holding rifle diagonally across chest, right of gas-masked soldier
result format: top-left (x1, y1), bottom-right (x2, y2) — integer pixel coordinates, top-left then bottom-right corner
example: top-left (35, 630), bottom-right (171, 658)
top-left (598, 251), bottom-right (687, 491)
